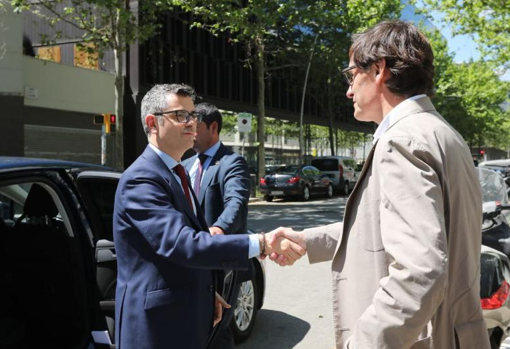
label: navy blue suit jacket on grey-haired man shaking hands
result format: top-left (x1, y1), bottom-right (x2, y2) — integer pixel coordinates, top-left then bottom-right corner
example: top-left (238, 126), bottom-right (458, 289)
top-left (113, 147), bottom-right (249, 349)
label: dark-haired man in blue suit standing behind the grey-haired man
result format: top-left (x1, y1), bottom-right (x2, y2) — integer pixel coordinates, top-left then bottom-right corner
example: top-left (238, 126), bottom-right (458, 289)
top-left (183, 103), bottom-right (250, 349)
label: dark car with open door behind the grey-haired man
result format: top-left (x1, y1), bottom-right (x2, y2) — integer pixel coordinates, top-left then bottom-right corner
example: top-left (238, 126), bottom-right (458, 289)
top-left (0, 157), bottom-right (265, 349)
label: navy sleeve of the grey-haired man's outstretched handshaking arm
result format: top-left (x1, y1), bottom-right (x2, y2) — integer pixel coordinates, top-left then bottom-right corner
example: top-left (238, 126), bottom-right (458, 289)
top-left (115, 177), bottom-right (249, 269)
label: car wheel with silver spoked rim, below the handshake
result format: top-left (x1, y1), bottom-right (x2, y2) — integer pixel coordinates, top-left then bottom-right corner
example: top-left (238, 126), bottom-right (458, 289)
top-left (230, 276), bottom-right (258, 344)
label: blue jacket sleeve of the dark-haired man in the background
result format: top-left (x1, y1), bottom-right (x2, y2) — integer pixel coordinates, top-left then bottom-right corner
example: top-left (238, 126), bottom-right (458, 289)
top-left (212, 156), bottom-right (250, 234)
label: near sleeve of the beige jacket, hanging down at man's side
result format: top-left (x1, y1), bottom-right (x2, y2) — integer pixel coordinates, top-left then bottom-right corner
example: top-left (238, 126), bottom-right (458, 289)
top-left (347, 137), bottom-right (448, 349)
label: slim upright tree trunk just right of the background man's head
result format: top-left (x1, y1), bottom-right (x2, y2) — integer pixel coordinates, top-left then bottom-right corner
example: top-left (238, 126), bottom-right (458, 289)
top-left (255, 37), bottom-right (266, 178)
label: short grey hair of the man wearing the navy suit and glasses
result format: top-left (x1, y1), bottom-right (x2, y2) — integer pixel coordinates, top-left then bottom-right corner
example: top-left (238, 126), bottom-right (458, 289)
top-left (141, 84), bottom-right (197, 135)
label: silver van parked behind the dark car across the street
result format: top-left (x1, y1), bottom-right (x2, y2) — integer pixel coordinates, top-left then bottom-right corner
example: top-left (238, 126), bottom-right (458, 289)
top-left (311, 156), bottom-right (359, 195)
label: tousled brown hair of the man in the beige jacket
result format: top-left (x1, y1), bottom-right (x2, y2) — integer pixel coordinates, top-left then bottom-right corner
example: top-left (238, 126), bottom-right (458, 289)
top-left (349, 20), bottom-right (434, 97)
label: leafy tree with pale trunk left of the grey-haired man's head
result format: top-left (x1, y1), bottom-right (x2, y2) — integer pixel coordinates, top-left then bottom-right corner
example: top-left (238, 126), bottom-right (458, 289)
top-left (9, 0), bottom-right (166, 170)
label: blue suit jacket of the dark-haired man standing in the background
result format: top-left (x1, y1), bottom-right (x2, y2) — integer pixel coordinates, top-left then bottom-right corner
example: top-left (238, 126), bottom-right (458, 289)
top-left (183, 144), bottom-right (250, 234)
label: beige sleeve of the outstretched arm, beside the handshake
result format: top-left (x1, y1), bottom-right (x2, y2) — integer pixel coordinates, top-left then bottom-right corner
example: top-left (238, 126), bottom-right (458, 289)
top-left (304, 222), bottom-right (343, 264)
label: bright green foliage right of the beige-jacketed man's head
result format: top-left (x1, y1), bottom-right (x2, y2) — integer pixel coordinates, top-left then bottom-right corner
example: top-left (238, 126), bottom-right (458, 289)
top-left (427, 25), bottom-right (510, 149)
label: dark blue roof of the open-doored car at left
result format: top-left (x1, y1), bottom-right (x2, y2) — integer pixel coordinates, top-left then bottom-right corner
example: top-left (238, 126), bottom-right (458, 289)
top-left (0, 156), bottom-right (114, 171)
